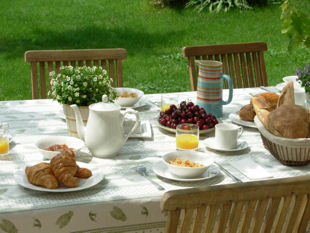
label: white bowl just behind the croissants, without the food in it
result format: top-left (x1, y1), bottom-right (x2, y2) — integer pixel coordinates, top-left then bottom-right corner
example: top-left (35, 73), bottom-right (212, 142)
top-left (35, 136), bottom-right (85, 159)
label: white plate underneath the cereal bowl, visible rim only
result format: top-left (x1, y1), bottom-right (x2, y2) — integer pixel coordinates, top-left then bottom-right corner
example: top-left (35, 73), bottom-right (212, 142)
top-left (153, 161), bottom-right (220, 182)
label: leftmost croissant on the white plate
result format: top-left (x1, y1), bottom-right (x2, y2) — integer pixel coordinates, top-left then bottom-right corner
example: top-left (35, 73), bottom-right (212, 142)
top-left (25, 163), bottom-right (58, 189)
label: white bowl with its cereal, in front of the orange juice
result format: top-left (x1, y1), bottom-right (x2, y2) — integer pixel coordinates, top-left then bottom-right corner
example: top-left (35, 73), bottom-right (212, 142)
top-left (163, 151), bottom-right (213, 178)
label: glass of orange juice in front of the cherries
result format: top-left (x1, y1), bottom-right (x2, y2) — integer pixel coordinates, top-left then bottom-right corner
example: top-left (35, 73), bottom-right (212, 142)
top-left (176, 123), bottom-right (199, 150)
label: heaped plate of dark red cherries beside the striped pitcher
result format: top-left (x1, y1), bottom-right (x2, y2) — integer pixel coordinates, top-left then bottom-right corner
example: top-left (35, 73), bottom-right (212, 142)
top-left (158, 101), bottom-right (218, 133)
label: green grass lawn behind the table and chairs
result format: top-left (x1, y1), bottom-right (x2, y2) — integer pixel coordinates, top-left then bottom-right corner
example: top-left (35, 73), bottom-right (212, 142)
top-left (0, 0), bottom-right (310, 100)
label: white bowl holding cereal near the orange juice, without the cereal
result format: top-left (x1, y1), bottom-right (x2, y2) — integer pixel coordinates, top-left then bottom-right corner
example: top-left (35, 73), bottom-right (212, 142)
top-left (163, 151), bottom-right (213, 178)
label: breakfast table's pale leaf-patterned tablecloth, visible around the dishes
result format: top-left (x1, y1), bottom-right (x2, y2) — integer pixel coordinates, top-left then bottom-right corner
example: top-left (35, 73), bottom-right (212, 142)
top-left (0, 88), bottom-right (310, 233)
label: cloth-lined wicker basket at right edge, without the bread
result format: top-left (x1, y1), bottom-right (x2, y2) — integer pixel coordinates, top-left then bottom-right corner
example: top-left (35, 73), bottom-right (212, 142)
top-left (254, 116), bottom-right (310, 166)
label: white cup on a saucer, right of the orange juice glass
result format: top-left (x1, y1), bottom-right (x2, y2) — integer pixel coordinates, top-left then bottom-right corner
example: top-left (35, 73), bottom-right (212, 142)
top-left (215, 123), bottom-right (243, 149)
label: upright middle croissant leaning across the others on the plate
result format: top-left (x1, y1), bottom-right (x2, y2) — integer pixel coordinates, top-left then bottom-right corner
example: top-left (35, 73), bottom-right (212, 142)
top-left (50, 150), bottom-right (80, 188)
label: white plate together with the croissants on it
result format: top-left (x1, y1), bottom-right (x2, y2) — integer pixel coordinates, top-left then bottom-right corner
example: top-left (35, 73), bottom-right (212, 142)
top-left (14, 151), bottom-right (104, 192)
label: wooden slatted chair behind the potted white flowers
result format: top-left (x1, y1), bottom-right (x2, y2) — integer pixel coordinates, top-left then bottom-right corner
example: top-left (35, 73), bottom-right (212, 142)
top-left (25, 48), bottom-right (127, 99)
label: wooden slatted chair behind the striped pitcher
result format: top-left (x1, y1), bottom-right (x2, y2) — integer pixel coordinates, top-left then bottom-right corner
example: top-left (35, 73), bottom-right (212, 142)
top-left (183, 42), bottom-right (268, 91)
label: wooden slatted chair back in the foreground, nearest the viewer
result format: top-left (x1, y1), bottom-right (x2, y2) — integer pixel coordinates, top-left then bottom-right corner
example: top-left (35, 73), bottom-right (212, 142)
top-left (160, 175), bottom-right (310, 233)
